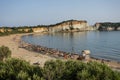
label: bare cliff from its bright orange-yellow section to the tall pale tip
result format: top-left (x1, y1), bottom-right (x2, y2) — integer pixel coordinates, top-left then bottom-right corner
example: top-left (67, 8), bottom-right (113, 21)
top-left (27, 20), bottom-right (91, 32)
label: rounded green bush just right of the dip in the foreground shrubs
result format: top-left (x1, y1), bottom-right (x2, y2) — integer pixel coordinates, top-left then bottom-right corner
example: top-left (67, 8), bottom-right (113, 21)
top-left (43, 60), bottom-right (65, 80)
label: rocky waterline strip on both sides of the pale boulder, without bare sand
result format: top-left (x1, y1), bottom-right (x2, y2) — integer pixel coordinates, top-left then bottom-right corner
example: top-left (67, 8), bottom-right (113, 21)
top-left (19, 34), bottom-right (120, 71)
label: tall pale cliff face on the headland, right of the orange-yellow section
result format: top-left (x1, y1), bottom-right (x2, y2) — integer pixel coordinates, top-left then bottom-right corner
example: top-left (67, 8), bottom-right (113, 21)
top-left (49, 20), bottom-right (88, 32)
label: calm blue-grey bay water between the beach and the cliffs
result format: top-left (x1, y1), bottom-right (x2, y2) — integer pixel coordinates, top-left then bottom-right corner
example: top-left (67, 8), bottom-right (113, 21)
top-left (22, 31), bottom-right (120, 61)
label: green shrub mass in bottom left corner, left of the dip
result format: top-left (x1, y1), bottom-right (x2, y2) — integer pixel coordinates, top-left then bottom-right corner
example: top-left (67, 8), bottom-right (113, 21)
top-left (0, 59), bottom-right (42, 80)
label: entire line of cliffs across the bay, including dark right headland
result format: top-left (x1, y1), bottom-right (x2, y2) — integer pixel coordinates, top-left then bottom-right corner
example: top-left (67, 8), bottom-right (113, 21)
top-left (0, 20), bottom-right (120, 34)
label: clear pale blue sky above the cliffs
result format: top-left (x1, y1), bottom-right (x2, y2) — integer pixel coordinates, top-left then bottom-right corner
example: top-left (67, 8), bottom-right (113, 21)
top-left (0, 0), bottom-right (120, 27)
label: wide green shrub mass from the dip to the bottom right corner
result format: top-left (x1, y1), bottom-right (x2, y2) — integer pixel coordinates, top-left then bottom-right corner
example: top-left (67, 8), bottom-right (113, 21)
top-left (43, 60), bottom-right (120, 80)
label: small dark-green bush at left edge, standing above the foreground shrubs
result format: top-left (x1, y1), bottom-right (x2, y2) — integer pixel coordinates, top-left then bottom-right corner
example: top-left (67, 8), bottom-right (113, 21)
top-left (0, 46), bottom-right (11, 61)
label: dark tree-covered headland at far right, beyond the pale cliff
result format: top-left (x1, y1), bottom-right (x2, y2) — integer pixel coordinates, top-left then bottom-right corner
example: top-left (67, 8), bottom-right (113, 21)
top-left (94, 22), bottom-right (120, 31)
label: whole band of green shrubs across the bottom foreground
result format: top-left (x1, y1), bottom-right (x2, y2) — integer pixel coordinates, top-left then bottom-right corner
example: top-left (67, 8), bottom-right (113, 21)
top-left (0, 45), bottom-right (120, 80)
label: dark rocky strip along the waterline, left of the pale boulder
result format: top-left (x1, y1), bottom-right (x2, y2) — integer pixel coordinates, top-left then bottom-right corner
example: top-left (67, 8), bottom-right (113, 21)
top-left (19, 41), bottom-right (83, 60)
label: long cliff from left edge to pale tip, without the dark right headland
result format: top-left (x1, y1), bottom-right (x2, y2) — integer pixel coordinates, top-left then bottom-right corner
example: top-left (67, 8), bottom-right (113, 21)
top-left (0, 20), bottom-right (91, 33)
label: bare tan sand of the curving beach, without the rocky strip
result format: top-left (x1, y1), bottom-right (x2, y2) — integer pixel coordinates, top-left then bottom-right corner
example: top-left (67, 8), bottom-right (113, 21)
top-left (0, 34), bottom-right (55, 66)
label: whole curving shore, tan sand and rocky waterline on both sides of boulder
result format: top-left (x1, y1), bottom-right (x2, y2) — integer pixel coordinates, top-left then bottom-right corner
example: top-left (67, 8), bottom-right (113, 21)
top-left (0, 33), bottom-right (120, 71)
